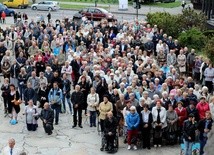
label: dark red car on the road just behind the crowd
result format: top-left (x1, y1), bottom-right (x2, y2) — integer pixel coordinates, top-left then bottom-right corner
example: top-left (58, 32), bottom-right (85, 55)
top-left (73, 7), bottom-right (115, 21)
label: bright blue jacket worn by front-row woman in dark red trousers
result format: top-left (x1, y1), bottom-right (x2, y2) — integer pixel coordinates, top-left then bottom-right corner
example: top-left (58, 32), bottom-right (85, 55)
top-left (126, 112), bottom-right (140, 130)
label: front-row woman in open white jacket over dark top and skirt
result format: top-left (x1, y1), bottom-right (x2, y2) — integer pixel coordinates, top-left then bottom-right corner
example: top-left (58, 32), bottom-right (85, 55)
top-left (152, 100), bottom-right (167, 148)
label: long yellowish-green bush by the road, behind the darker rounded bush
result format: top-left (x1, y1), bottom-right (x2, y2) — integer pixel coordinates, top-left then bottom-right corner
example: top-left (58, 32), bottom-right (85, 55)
top-left (147, 9), bottom-right (206, 38)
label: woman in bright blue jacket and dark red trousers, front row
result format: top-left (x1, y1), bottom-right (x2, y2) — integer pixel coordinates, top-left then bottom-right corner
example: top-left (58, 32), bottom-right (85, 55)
top-left (126, 106), bottom-right (140, 150)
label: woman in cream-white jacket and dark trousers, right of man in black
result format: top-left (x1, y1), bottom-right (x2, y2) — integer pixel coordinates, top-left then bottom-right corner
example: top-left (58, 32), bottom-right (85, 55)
top-left (87, 87), bottom-right (99, 127)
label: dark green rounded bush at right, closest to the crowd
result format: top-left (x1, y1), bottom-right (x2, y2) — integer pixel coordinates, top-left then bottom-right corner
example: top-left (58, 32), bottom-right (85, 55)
top-left (178, 28), bottom-right (207, 51)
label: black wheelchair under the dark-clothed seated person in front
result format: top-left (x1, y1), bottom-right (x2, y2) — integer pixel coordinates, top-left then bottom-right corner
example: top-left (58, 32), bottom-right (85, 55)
top-left (100, 133), bottom-right (119, 153)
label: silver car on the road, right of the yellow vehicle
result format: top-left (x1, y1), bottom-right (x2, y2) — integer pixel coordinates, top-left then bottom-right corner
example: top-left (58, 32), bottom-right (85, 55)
top-left (31, 1), bottom-right (60, 11)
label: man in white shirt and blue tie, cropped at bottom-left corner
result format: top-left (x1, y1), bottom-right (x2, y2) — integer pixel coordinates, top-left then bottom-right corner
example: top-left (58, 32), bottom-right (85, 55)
top-left (2, 138), bottom-right (21, 155)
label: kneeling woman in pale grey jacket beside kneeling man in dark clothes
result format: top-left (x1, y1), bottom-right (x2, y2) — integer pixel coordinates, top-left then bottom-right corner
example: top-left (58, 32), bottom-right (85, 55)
top-left (23, 100), bottom-right (39, 131)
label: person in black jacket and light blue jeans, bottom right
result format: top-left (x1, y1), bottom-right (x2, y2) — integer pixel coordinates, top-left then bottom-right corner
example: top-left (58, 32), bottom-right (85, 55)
top-left (183, 114), bottom-right (197, 155)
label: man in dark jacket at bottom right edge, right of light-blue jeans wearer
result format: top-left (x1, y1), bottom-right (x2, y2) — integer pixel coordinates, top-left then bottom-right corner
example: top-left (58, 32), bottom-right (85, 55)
top-left (198, 111), bottom-right (213, 155)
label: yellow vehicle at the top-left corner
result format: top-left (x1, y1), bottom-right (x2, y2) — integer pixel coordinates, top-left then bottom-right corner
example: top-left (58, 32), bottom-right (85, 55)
top-left (3, 0), bottom-right (29, 9)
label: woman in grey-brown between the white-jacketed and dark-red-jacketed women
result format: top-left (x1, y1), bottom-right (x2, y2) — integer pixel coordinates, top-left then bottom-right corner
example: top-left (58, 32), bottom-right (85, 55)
top-left (166, 105), bottom-right (178, 144)
